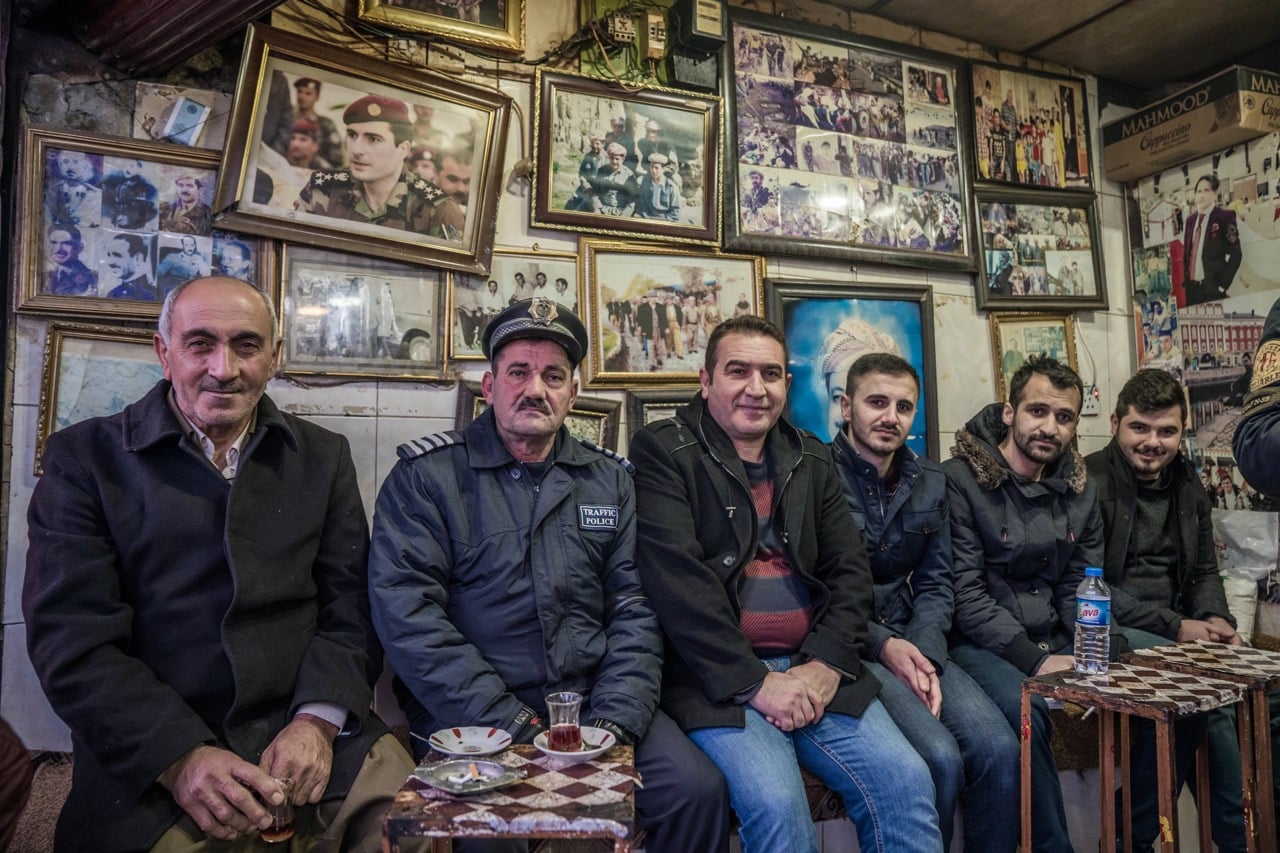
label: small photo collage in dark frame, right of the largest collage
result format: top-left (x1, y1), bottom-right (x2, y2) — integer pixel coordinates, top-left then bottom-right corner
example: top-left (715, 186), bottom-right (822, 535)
top-left (979, 201), bottom-right (1098, 297)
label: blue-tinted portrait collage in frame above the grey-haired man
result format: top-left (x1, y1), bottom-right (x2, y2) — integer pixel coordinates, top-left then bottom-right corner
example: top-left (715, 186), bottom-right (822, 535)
top-left (40, 147), bottom-right (257, 302)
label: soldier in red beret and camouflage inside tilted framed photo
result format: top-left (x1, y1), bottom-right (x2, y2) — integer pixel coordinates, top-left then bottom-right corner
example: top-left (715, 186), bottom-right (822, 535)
top-left (294, 95), bottom-right (465, 241)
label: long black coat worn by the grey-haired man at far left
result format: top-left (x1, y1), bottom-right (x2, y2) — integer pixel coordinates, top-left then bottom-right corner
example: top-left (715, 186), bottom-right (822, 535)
top-left (23, 380), bottom-right (387, 853)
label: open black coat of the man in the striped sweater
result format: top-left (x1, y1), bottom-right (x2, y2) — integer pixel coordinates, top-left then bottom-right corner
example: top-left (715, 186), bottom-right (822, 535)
top-left (631, 394), bottom-right (879, 731)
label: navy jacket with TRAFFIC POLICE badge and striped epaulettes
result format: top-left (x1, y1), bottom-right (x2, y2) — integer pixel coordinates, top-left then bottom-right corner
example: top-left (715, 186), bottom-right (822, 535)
top-left (369, 409), bottom-right (662, 738)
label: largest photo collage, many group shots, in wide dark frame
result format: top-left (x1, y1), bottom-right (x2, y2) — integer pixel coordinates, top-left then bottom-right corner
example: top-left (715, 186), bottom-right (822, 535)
top-left (733, 24), bottom-right (965, 255)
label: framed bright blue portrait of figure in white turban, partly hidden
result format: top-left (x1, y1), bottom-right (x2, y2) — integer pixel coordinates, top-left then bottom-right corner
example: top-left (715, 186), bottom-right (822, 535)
top-left (767, 279), bottom-right (938, 460)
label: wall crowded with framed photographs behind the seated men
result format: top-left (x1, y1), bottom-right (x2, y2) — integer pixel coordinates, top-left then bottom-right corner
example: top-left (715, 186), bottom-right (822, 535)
top-left (0, 0), bottom-right (1162, 748)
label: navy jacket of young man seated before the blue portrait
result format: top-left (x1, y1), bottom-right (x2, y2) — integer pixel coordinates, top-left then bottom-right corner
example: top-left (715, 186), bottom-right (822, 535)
top-left (831, 432), bottom-right (955, 671)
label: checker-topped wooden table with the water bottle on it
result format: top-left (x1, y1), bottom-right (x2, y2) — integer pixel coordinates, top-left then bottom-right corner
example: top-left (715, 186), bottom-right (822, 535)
top-left (1020, 662), bottom-right (1244, 853)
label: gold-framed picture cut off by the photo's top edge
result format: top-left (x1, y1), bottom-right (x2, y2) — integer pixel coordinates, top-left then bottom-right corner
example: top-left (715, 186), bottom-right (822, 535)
top-left (360, 0), bottom-right (525, 53)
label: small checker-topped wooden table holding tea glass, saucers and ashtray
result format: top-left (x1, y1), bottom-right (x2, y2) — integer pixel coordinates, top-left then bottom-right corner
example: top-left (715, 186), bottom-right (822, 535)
top-left (383, 744), bottom-right (639, 853)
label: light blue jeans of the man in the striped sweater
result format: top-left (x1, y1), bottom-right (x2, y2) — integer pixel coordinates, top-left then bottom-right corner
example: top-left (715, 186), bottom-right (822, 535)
top-left (689, 657), bottom-right (942, 853)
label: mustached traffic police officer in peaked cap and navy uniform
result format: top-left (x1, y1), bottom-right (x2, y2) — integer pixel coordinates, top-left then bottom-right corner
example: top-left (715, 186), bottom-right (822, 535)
top-left (369, 297), bottom-right (728, 853)
